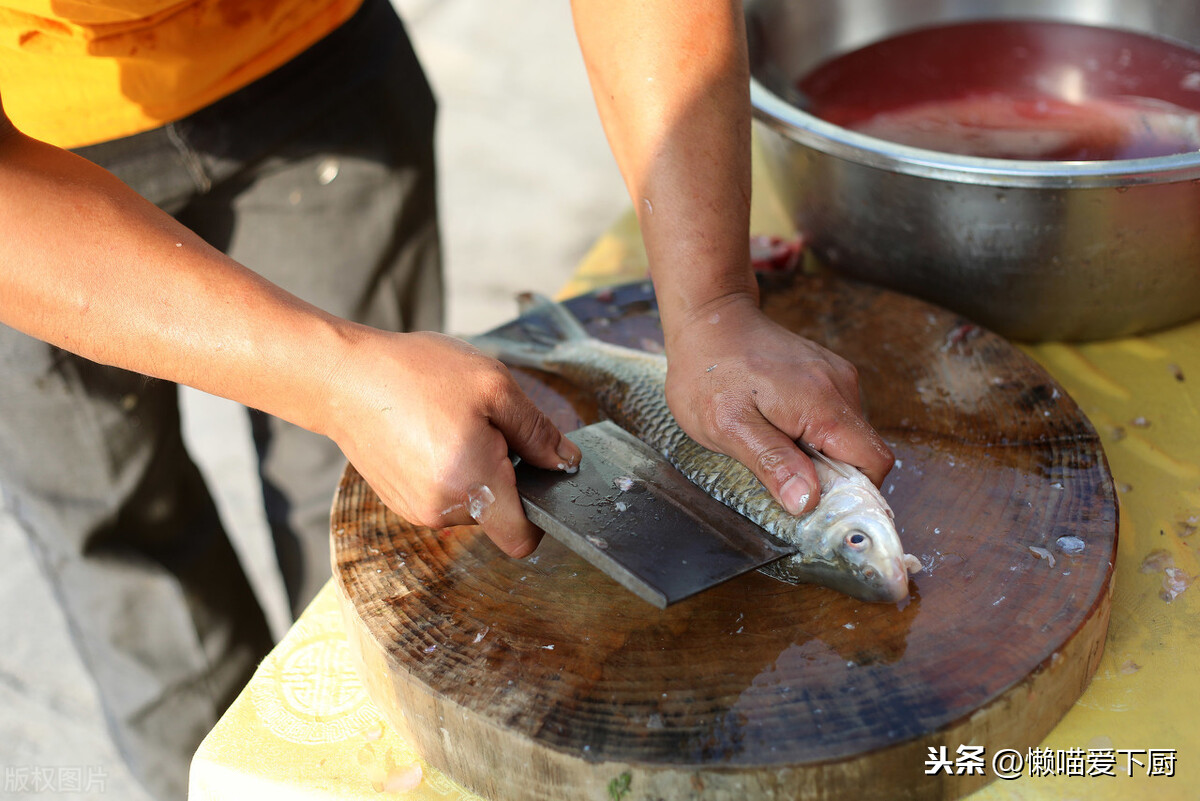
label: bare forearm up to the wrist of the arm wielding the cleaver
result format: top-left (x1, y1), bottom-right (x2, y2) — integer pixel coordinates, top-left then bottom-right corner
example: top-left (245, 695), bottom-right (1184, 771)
top-left (0, 127), bottom-right (356, 430)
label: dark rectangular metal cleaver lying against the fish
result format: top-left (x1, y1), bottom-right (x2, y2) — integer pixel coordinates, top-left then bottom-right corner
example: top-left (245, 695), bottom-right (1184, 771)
top-left (516, 421), bottom-right (797, 609)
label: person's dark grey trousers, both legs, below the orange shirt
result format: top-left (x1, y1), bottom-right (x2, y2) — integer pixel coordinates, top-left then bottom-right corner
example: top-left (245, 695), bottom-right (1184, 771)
top-left (0, 0), bottom-right (442, 799)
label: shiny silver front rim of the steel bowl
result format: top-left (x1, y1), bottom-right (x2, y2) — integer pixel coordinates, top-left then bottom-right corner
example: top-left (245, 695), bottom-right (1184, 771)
top-left (750, 76), bottom-right (1200, 188)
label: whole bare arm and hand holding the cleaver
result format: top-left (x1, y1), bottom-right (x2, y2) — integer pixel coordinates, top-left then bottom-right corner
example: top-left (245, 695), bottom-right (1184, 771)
top-left (0, 97), bottom-right (580, 556)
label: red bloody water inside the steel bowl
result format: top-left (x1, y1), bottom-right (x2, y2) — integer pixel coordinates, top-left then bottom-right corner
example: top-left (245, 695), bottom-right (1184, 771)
top-left (797, 20), bottom-right (1200, 161)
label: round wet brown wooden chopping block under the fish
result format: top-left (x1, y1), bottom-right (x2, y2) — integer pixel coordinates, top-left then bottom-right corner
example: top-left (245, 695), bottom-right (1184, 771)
top-left (332, 278), bottom-right (1117, 801)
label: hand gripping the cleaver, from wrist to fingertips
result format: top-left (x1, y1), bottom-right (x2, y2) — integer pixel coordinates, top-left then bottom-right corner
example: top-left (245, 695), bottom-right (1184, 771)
top-left (328, 331), bottom-right (580, 558)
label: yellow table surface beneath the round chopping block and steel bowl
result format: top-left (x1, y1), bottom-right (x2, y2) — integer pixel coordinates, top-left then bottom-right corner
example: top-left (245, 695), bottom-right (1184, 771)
top-left (191, 153), bottom-right (1200, 801)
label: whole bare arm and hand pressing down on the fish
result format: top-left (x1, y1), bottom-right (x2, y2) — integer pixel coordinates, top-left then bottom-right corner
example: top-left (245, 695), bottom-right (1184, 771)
top-left (572, 9), bottom-right (892, 501)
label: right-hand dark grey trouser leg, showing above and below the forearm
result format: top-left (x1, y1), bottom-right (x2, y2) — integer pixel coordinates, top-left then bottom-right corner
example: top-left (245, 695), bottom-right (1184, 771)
top-left (180, 0), bottom-right (443, 612)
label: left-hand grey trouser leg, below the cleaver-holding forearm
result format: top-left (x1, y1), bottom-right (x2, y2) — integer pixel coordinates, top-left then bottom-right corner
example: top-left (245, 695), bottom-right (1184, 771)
top-left (0, 326), bottom-right (270, 799)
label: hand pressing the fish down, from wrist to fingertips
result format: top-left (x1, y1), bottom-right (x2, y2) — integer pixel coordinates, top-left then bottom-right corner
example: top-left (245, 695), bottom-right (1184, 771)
top-left (666, 295), bottom-right (894, 514)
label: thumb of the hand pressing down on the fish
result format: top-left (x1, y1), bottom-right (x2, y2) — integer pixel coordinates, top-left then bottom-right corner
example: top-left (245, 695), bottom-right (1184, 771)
top-left (727, 417), bottom-right (821, 514)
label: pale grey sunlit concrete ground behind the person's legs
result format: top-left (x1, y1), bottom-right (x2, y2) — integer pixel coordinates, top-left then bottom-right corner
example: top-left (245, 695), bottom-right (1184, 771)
top-left (0, 0), bottom-right (628, 801)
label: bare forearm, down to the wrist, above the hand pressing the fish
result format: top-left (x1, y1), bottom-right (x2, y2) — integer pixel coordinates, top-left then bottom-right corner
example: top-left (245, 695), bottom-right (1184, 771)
top-left (574, 0), bottom-right (757, 344)
